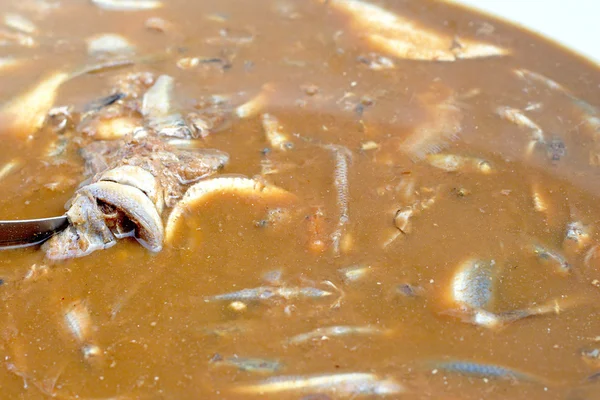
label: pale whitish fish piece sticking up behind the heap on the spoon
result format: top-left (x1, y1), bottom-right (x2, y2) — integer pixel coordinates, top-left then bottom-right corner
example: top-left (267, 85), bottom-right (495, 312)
top-left (142, 75), bottom-right (192, 138)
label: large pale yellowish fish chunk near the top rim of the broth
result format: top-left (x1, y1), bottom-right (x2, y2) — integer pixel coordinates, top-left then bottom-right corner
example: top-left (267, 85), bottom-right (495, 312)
top-left (328, 0), bottom-right (510, 62)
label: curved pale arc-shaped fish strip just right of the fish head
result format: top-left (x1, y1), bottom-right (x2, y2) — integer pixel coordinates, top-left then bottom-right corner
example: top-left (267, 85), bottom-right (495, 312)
top-left (165, 177), bottom-right (295, 244)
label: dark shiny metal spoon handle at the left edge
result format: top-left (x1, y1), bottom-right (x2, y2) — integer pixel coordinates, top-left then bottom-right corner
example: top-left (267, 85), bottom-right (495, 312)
top-left (0, 215), bottom-right (69, 250)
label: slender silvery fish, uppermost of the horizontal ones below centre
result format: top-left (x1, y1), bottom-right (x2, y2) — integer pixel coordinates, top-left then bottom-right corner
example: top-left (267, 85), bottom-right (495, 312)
top-left (204, 286), bottom-right (333, 303)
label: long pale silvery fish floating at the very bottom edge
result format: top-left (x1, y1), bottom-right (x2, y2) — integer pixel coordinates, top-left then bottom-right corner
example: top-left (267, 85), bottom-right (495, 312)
top-left (233, 372), bottom-right (406, 398)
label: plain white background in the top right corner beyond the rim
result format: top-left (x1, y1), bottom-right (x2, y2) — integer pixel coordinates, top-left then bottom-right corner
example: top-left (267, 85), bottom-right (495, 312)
top-left (450, 0), bottom-right (600, 63)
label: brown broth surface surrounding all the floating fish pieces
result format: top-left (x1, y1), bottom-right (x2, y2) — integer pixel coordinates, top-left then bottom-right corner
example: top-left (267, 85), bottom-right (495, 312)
top-left (0, 0), bottom-right (600, 400)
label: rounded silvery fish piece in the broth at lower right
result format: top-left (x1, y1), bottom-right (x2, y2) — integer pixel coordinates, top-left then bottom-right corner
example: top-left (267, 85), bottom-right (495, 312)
top-left (451, 259), bottom-right (497, 309)
